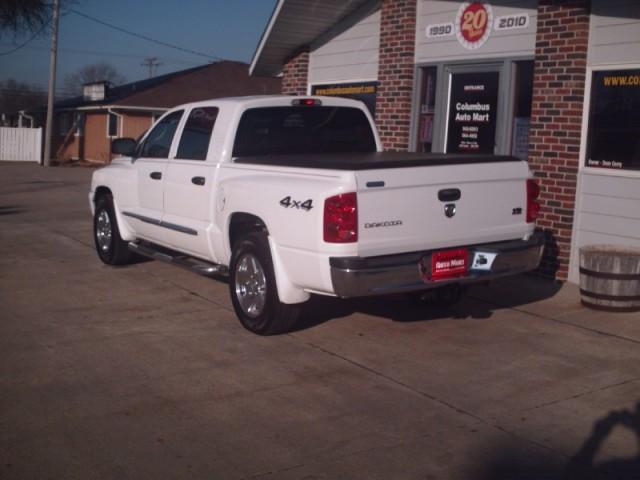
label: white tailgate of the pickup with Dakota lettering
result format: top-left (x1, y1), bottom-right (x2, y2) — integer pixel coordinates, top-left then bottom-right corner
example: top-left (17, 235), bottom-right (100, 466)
top-left (355, 161), bottom-right (532, 257)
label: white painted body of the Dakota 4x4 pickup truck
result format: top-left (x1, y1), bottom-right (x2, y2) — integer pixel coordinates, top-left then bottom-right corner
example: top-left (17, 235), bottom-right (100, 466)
top-left (89, 96), bottom-right (542, 334)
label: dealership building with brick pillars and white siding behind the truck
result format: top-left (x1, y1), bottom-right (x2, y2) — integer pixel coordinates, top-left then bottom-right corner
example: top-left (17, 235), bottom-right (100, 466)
top-left (251, 0), bottom-right (640, 282)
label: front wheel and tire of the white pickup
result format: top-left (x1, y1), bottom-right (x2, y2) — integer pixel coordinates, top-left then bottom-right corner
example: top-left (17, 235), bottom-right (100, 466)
top-left (93, 195), bottom-right (133, 265)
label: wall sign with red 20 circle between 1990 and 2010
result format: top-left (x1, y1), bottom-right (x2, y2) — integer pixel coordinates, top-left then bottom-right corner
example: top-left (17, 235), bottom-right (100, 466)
top-left (425, 2), bottom-right (529, 50)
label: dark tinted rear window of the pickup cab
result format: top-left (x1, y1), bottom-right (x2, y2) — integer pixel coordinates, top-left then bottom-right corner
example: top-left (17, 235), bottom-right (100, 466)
top-left (233, 106), bottom-right (376, 157)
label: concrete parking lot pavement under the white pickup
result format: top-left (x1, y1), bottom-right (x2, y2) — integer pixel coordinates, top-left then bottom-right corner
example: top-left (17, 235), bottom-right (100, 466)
top-left (0, 162), bottom-right (640, 480)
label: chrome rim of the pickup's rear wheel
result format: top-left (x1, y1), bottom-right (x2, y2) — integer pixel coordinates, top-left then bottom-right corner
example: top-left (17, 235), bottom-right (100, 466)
top-left (235, 253), bottom-right (267, 318)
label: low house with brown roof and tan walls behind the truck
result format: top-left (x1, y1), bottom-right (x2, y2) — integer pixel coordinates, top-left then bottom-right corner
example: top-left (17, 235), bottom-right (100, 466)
top-left (22, 60), bottom-right (281, 164)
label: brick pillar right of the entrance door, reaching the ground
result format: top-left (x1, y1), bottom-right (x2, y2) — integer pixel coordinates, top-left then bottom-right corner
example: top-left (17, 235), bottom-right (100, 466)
top-left (529, 0), bottom-right (590, 280)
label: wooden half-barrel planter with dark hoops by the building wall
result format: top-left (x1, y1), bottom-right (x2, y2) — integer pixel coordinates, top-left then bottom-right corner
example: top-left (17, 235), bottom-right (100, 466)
top-left (580, 245), bottom-right (640, 312)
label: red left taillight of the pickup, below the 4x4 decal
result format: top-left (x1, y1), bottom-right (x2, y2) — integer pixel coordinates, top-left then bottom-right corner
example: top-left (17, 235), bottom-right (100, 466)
top-left (324, 192), bottom-right (358, 243)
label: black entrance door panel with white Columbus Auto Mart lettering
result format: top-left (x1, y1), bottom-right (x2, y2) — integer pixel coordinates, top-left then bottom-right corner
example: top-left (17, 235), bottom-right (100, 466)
top-left (447, 72), bottom-right (500, 153)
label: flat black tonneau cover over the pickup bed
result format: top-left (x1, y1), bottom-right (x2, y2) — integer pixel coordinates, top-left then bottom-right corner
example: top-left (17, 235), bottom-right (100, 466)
top-left (233, 152), bottom-right (522, 170)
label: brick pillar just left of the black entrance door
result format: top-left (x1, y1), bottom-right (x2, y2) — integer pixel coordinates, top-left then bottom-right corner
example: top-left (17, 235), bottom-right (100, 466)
top-left (376, 0), bottom-right (417, 151)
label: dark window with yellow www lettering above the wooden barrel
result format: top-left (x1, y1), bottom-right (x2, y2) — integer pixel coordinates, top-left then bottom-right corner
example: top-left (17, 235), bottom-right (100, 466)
top-left (586, 69), bottom-right (640, 170)
